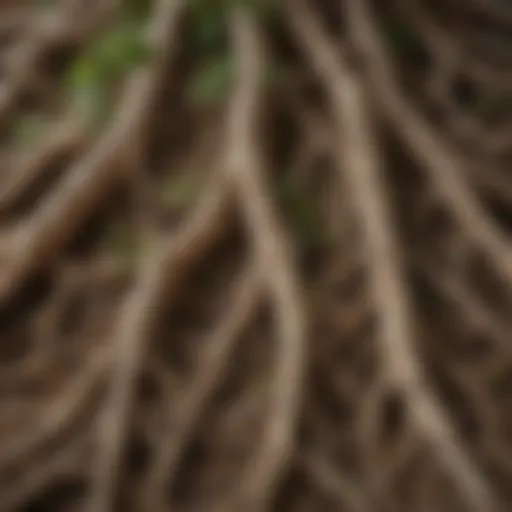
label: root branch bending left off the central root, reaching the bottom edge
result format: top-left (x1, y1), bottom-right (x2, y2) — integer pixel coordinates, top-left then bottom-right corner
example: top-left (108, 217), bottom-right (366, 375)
top-left (89, 176), bottom-right (229, 512)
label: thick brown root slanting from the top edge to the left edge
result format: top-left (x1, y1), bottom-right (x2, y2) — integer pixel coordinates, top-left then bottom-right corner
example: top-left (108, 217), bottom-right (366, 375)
top-left (0, 0), bottom-right (184, 305)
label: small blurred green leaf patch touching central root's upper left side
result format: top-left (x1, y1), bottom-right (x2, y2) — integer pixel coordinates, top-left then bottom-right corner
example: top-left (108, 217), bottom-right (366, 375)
top-left (188, 56), bottom-right (233, 104)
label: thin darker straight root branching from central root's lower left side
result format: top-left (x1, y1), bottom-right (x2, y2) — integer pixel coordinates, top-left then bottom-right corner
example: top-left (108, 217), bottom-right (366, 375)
top-left (145, 267), bottom-right (261, 511)
